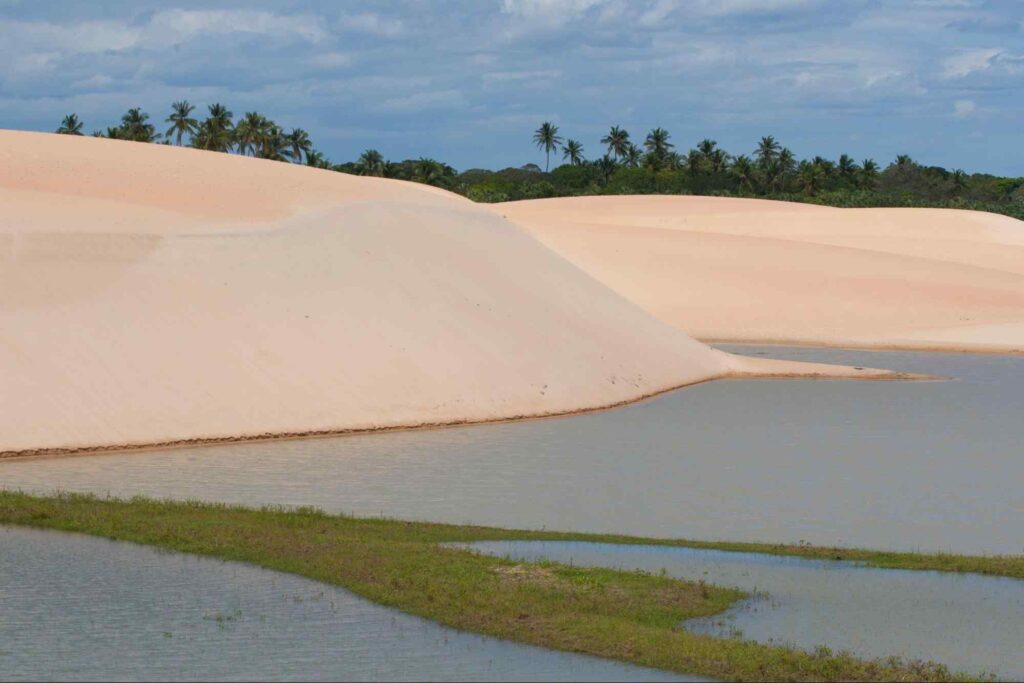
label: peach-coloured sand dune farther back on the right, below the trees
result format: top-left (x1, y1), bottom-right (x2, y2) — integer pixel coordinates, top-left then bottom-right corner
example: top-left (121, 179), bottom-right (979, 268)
top-left (494, 192), bottom-right (1024, 352)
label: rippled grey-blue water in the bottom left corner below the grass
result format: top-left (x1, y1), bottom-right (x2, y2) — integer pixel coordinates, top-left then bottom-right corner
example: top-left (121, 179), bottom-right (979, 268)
top-left (0, 527), bottom-right (695, 681)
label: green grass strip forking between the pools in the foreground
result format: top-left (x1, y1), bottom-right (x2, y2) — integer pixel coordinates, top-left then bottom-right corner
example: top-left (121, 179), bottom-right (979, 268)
top-left (0, 492), bottom-right (999, 681)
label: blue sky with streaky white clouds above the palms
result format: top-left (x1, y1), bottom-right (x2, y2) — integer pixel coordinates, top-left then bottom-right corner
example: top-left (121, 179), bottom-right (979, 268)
top-left (0, 0), bottom-right (1024, 176)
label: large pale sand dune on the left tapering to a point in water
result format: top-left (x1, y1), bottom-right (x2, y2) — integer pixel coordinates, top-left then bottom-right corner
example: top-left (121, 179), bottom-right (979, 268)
top-left (0, 131), bottom-right (905, 455)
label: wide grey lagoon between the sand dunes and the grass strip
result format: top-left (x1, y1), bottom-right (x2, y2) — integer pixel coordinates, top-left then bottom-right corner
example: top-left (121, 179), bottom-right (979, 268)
top-left (0, 347), bottom-right (1024, 554)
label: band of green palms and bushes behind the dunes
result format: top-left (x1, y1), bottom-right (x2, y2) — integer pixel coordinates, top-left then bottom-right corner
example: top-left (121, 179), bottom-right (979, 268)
top-left (56, 107), bottom-right (1024, 219)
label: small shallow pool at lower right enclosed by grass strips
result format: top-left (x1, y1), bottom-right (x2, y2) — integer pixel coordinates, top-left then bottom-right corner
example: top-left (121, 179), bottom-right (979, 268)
top-left (472, 542), bottom-right (1024, 680)
